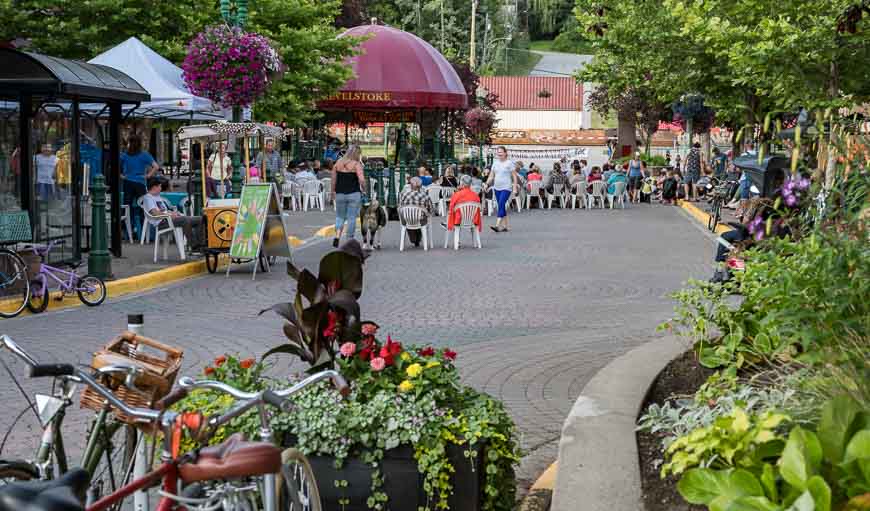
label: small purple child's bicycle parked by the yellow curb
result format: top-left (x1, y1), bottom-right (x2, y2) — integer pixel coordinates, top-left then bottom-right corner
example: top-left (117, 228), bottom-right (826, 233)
top-left (27, 242), bottom-right (106, 313)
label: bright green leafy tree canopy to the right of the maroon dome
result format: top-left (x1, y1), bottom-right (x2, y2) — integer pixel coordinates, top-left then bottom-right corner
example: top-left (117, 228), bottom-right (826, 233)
top-left (575, 0), bottom-right (870, 140)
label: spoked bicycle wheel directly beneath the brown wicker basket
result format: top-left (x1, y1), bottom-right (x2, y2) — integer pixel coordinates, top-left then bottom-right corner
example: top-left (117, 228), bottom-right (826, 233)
top-left (82, 421), bottom-right (136, 509)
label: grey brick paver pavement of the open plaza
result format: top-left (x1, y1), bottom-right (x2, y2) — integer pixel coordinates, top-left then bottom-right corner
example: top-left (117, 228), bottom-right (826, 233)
top-left (0, 205), bottom-right (712, 500)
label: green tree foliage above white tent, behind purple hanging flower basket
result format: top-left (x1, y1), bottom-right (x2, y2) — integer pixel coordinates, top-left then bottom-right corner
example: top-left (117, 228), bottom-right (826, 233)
top-left (0, 0), bottom-right (355, 122)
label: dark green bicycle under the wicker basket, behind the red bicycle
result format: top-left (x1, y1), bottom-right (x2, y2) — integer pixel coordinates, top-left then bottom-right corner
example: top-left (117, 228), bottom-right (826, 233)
top-left (0, 335), bottom-right (139, 508)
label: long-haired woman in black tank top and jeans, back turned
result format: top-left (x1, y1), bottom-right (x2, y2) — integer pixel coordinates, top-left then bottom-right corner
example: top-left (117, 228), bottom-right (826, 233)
top-left (332, 145), bottom-right (366, 247)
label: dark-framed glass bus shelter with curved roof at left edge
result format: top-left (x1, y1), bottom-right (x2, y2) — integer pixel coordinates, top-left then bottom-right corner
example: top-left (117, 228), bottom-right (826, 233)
top-left (0, 48), bottom-right (151, 260)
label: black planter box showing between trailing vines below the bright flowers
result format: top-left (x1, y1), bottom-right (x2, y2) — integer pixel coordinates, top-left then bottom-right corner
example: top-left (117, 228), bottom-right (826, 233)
top-left (300, 444), bottom-right (485, 511)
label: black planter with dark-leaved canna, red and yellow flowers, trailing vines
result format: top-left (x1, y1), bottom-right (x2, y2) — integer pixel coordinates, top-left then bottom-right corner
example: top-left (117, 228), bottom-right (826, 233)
top-left (264, 241), bottom-right (519, 511)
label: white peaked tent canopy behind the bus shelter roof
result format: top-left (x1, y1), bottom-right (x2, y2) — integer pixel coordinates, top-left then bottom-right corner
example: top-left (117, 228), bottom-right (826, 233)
top-left (83, 37), bottom-right (224, 120)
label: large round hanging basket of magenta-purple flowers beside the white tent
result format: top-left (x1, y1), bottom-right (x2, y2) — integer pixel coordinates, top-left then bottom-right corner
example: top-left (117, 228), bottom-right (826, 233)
top-left (182, 25), bottom-right (284, 108)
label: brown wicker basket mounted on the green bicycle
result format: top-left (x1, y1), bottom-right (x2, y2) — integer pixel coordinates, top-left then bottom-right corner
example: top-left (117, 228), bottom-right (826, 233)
top-left (81, 332), bottom-right (184, 425)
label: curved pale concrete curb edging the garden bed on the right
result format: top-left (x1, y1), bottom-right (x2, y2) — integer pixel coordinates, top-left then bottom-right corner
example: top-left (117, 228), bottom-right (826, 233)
top-left (551, 337), bottom-right (689, 511)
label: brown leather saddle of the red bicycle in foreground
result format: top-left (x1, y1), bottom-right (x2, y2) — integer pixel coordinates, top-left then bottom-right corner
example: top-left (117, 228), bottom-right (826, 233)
top-left (178, 433), bottom-right (281, 483)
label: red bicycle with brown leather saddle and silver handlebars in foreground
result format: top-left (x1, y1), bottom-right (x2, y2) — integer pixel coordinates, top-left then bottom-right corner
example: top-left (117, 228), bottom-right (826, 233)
top-left (0, 340), bottom-right (349, 511)
